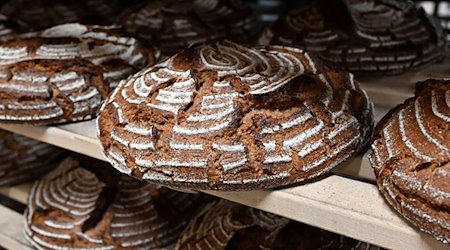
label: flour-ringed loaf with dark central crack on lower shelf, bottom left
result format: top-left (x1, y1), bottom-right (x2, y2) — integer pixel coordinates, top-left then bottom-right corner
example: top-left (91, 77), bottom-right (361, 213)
top-left (25, 157), bottom-right (207, 249)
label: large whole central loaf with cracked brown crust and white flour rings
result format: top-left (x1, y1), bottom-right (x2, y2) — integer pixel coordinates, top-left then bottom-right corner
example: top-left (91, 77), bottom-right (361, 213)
top-left (98, 41), bottom-right (372, 190)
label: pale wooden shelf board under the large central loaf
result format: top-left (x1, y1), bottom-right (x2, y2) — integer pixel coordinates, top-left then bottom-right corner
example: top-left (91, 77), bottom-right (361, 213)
top-left (0, 102), bottom-right (449, 249)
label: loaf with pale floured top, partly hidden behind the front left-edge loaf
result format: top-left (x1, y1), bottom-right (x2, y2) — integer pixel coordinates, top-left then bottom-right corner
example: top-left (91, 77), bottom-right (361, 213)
top-left (0, 23), bottom-right (155, 88)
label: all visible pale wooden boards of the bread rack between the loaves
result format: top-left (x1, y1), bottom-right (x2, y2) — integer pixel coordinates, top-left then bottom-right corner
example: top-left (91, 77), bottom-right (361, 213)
top-left (0, 56), bottom-right (450, 250)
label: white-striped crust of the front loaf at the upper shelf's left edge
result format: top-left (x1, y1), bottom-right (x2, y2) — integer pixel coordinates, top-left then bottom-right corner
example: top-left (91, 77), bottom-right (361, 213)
top-left (0, 61), bottom-right (102, 124)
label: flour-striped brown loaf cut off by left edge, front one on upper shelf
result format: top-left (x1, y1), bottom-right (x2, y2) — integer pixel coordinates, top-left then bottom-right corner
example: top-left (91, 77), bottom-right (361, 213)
top-left (0, 59), bottom-right (110, 125)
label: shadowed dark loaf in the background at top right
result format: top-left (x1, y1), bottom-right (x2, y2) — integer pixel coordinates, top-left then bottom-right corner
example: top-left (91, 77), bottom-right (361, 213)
top-left (259, 0), bottom-right (445, 74)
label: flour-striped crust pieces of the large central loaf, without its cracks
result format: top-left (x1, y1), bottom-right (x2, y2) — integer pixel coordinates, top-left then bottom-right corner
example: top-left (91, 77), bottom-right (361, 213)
top-left (103, 42), bottom-right (371, 189)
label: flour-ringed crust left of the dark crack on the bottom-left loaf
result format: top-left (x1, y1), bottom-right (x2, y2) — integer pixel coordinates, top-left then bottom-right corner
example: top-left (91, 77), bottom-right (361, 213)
top-left (25, 158), bottom-right (110, 249)
